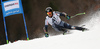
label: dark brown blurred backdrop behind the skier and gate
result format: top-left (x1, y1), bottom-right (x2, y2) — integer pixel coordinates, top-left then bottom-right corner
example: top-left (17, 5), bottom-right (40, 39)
top-left (0, 0), bottom-right (100, 45)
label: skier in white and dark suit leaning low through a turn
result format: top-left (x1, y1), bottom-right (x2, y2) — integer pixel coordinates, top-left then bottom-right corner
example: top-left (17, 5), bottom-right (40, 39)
top-left (44, 7), bottom-right (86, 37)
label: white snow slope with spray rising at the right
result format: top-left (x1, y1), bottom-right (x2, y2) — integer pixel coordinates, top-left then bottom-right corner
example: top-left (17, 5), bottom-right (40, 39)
top-left (0, 11), bottom-right (100, 49)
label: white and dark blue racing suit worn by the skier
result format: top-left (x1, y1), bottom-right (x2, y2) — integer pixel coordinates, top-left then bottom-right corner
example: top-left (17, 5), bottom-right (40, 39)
top-left (45, 11), bottom-right (83, 32)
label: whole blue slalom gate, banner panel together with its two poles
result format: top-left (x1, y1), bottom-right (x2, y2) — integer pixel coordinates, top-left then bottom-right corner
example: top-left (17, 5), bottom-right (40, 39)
top-left (1, 0), bottom-right (29, 44)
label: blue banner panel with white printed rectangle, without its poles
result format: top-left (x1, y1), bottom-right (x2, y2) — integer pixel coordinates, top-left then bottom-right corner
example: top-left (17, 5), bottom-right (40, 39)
top-left (2, 0), bottom-right (23, 17)
